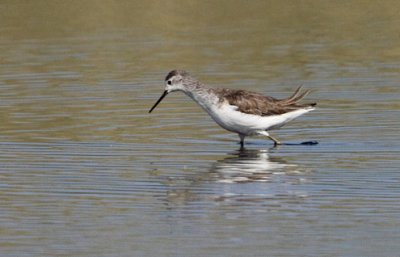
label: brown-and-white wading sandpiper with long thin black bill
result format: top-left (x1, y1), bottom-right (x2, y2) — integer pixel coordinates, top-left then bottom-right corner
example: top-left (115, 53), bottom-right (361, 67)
top-left (149, 70), bottom-right (316, 148)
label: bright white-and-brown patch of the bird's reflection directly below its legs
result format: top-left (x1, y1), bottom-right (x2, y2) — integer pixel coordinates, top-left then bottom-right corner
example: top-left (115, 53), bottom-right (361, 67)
top-left (211, 149), bottom-right (298, 183)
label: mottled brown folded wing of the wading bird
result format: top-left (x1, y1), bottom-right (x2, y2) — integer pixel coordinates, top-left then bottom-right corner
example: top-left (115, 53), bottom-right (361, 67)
top-left (216, 87), bottom-right (316, 116)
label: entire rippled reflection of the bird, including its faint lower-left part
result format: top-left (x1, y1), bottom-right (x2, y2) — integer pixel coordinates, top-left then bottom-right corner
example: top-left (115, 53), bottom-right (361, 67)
top-left (162, 149), bottom-right (309, 205)
